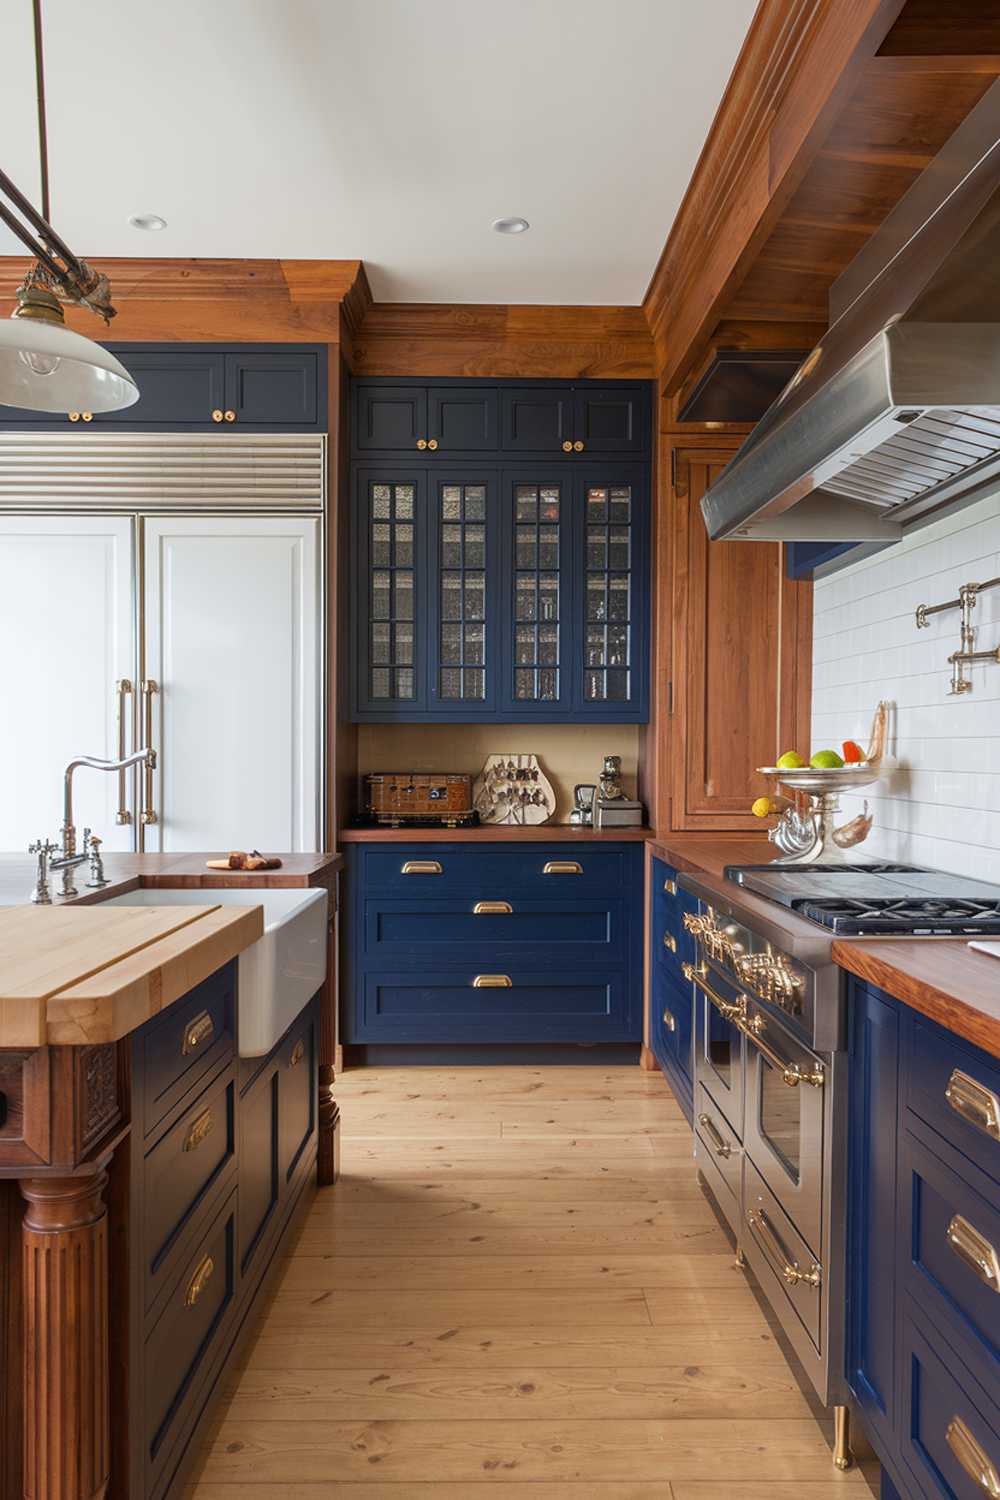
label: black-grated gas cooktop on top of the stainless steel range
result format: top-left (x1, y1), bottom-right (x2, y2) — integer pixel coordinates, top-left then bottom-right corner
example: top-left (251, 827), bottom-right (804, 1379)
top-left (726, 864), bottom-right (1000, 938)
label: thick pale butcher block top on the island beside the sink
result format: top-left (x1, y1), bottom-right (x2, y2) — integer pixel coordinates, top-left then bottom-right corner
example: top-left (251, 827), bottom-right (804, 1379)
top-left (0, 891), bottom-right (264, 1047)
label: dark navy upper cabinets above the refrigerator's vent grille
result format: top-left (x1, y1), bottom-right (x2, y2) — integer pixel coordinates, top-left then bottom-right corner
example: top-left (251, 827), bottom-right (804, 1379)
top-left (0, 344), bottom-right (327, 434)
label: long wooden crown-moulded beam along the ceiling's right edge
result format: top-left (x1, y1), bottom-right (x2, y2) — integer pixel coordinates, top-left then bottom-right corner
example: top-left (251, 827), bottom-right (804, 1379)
top-left (643, 0), bottom-right (903, 393)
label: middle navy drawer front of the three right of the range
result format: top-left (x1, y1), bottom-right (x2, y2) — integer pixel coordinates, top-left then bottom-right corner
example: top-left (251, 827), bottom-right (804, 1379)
top-left (900, 1131), bottom-right (1000, 1377)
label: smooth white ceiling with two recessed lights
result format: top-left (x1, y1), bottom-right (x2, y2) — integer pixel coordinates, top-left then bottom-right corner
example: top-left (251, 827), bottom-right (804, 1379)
top-left (0, 0), bottom-right (756, 303)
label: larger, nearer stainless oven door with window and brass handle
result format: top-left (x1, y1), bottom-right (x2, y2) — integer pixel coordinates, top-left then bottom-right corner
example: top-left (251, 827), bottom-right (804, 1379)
top-left (744, 1002), bottom-right (831, 1260)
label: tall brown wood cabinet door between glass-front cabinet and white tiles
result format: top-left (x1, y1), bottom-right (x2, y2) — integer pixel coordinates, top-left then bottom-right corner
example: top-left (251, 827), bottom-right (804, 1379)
top-left (670, 449), bottom-right (811, 831)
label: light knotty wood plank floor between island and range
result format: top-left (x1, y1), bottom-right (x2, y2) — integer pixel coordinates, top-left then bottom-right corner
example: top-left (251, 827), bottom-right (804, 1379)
top-left (190, 1067), bottom-right (873, 1500)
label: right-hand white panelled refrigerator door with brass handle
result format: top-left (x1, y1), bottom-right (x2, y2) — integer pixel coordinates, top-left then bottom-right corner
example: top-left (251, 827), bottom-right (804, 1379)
top-left (142, 516), bottom-right (321, 851)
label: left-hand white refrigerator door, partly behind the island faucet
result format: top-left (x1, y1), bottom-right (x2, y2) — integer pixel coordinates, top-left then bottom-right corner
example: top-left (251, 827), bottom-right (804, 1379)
top-left (0, 516), bottom-right (135, 852)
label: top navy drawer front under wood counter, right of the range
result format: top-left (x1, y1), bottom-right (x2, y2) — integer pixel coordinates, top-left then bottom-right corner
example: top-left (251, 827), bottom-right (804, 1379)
top-left (904, 1016), bottom-right (1000, 1182)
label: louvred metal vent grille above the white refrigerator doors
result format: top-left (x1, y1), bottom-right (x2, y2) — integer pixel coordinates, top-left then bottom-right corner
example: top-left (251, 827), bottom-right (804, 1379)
top-left (0, 432), bottom-right (327, 515)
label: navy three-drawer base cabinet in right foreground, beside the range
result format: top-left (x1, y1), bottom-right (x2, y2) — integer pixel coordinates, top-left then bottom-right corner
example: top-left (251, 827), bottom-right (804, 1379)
top-left (847, 981), bottom-right (1000, 1500)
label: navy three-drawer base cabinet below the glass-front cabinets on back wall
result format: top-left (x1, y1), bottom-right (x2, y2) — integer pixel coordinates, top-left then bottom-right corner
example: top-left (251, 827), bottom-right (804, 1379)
top-left (342, 840), bottom-right (643, 1044)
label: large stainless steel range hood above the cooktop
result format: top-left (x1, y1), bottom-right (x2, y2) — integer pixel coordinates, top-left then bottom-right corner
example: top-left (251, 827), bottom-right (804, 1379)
top-left (702, 81), bottom-right (1000, 543)
